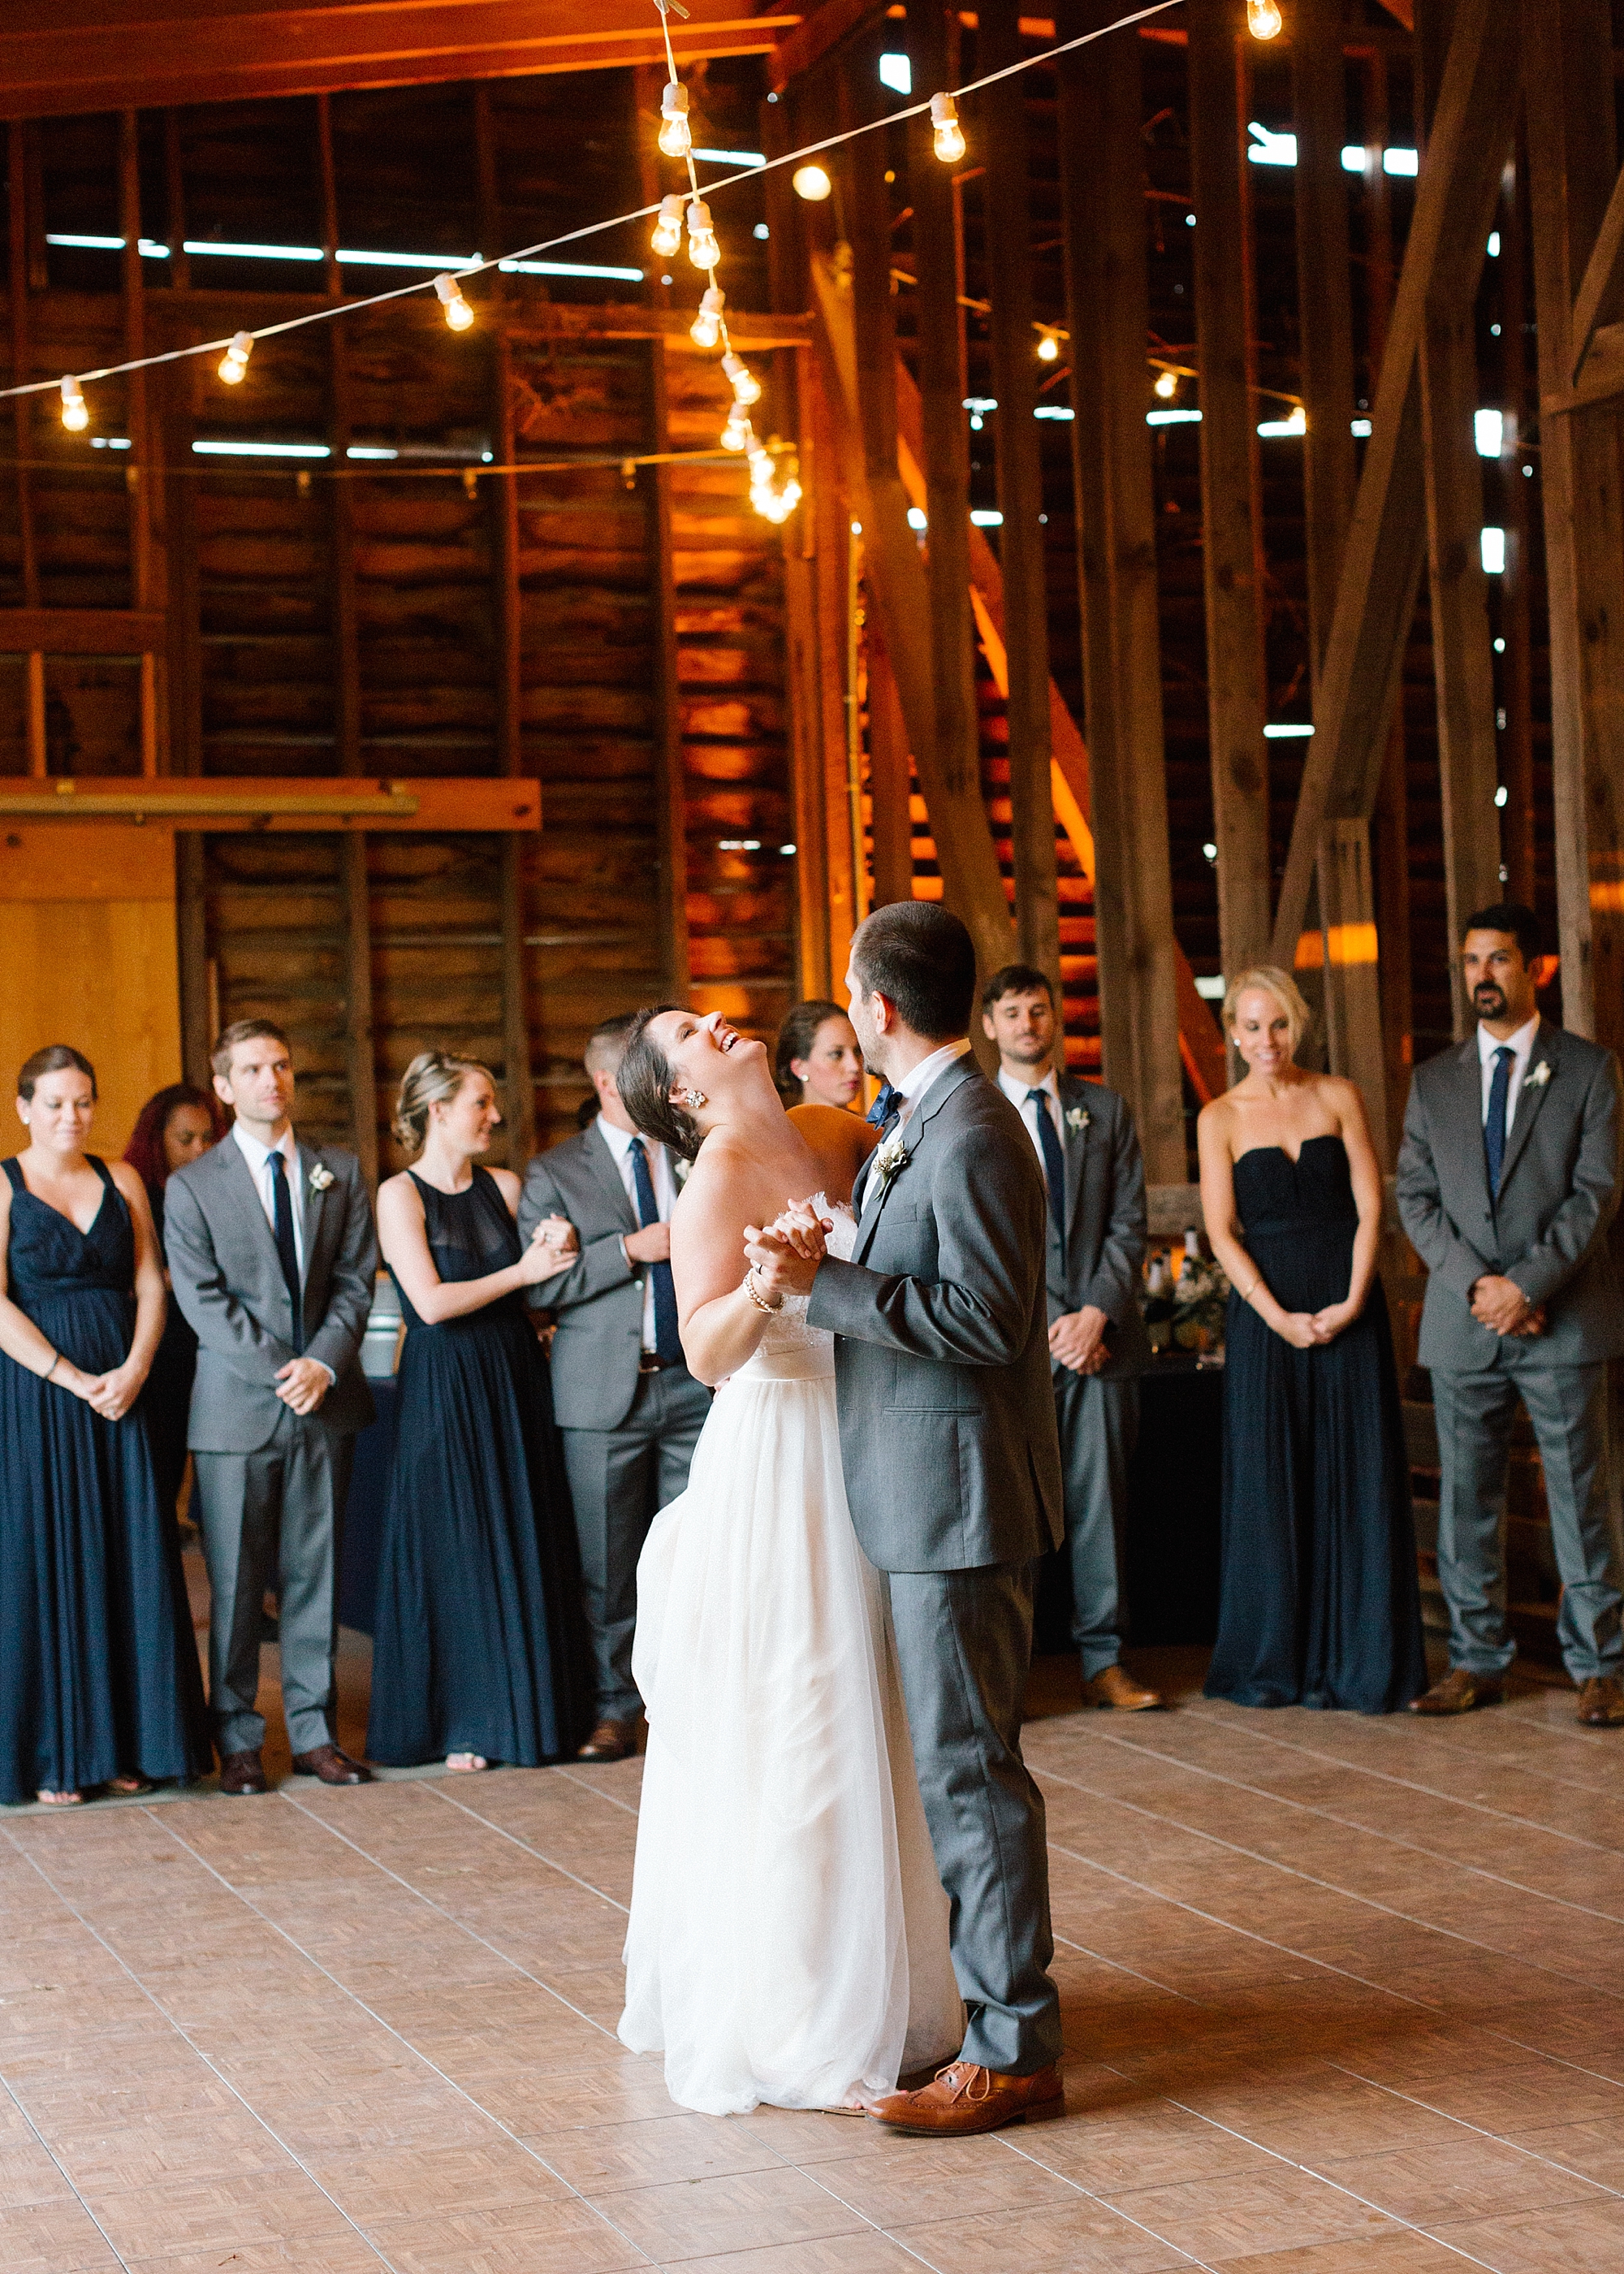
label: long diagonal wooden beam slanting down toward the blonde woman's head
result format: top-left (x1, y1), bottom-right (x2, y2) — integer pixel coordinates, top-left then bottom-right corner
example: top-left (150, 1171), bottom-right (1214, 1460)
top-left (1274, 0), bottom-right (1517, 969)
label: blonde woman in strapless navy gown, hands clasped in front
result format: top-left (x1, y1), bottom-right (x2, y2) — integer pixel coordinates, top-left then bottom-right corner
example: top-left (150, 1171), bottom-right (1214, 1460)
top-left (1199, 969), bottom-right (1426, 1712)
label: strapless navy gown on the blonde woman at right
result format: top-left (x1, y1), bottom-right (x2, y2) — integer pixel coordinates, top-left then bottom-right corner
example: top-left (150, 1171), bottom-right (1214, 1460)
top-left (1206, 1137), bottom-right (1426, 1712)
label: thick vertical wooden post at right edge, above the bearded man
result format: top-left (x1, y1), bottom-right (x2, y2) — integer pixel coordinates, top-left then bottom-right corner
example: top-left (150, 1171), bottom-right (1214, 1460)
top-left (1522, 0), bottom-right (1624, 1048)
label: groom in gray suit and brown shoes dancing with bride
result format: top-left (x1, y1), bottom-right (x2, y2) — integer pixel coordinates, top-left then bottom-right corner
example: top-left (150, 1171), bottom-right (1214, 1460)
top-left (746, 901), bottom-right (1062, 2135)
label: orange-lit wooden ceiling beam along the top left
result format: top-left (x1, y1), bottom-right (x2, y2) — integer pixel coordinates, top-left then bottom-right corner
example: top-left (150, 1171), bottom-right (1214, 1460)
top-left (0, 0), bottom-right (801, 119)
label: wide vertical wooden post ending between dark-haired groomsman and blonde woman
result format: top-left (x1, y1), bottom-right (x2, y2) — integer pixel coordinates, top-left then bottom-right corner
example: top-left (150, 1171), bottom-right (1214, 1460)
top-left (1058, 6), bottom-right (1190, 1185)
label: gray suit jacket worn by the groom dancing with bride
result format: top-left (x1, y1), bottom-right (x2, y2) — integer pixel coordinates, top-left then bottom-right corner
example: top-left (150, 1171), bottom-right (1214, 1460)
top-left (807, 1060), bottom-right (1065, 1571)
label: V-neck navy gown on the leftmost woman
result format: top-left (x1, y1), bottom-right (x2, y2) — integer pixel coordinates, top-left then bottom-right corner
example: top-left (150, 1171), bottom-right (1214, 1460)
top-left (0, 1155), bottom-right (214, 1801)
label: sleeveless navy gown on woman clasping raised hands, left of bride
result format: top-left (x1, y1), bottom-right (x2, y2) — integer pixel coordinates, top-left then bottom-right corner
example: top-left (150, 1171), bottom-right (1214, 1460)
top-left (366, 1169), bottom-right (591, 1767)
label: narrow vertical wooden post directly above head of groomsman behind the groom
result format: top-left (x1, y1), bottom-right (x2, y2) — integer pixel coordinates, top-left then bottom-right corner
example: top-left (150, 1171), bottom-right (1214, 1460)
top-left (966, 0), bottom-right (1060, 1001)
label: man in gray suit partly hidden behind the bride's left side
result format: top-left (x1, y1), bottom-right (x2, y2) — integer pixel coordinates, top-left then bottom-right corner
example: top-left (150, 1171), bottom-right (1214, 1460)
top-left (519, 1018), bottom-right (710, 1760)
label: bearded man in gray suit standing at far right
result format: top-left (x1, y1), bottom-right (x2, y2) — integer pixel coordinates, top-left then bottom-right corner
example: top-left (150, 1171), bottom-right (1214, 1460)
top-left (1399, 903), bottom-right (1624, 1728)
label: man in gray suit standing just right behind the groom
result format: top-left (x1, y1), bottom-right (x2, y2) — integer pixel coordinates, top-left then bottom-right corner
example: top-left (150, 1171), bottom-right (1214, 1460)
top-left (980, 964), bottom-right (1162, 1712)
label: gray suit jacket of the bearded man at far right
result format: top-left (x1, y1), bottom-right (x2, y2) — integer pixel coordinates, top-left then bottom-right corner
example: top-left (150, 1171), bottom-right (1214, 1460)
top-left (1397, 1018), bottom-right (1624, 1373)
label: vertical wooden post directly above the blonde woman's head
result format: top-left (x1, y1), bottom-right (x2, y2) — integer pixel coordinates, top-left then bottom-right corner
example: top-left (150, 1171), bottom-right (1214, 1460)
top-left (1187, 0), bottom-right (1269, 973)
